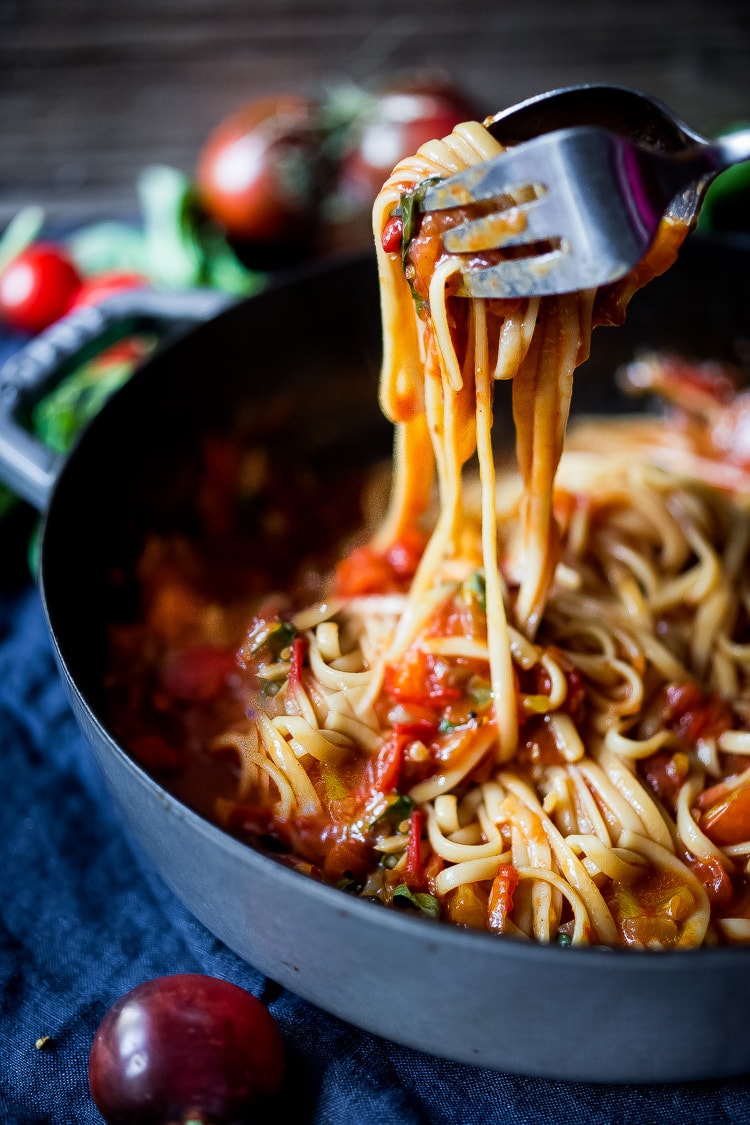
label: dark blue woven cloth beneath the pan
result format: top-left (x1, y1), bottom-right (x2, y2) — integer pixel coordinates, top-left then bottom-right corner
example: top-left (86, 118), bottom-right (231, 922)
top-left (0, 328), bottom-right (750, 1125)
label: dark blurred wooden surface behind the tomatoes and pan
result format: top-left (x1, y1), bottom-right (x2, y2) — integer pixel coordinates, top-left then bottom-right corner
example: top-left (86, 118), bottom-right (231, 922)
top-left (0, 0), bottom-right (750, 224)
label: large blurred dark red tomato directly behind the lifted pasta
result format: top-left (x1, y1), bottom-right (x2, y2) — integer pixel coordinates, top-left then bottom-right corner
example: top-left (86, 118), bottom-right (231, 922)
top-left (341, 81), bottom-right (477, 204)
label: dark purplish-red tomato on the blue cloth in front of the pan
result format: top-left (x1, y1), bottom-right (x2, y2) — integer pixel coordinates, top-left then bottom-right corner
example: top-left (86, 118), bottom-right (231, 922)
top-left (89, 973), bottom-right (284, 1125)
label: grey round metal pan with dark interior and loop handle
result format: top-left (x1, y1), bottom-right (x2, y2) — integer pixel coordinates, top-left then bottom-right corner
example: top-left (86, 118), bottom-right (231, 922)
top-left (0, 236), bottom-right (750, 1082)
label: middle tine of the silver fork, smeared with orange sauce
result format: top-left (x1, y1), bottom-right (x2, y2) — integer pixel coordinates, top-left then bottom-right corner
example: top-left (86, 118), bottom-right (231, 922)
top-left (443, 196), bottom-right (567, 254)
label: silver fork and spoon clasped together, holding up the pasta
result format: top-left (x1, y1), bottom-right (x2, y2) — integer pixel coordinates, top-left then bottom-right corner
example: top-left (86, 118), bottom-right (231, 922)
top-left (421, 84), bottom-right (750, 298)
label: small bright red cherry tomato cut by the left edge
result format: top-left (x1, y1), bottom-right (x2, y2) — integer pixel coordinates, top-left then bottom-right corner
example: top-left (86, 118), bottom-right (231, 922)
top-left (0, 242), bottom-right (81, 333)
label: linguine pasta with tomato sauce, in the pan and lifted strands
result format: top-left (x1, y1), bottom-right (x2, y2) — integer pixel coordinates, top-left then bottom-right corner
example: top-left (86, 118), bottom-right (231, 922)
top-left (106, 123), bottom-right (750, 950)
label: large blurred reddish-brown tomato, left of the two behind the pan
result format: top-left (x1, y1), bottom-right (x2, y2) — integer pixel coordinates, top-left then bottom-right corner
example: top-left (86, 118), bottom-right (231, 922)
top-left (196, 95), bottom-right (319, 243)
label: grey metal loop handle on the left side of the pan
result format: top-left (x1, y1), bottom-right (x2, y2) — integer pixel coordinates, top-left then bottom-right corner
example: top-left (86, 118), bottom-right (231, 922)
top-left (0, 289), bottom-right (237, 512)
